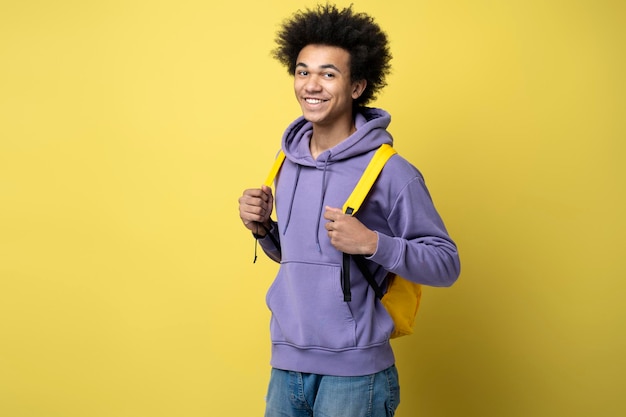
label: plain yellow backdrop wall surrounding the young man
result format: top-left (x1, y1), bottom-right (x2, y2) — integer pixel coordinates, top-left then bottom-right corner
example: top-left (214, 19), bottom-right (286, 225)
top-left (0, 0), bottom-right (626, 417)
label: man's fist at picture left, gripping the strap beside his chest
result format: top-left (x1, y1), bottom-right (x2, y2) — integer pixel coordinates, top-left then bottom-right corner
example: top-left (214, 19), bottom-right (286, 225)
top-left (239, 185), bottom-right (274, 236)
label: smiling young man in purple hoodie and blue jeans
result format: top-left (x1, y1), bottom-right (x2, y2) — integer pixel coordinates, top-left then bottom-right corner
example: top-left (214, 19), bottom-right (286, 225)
top-left (239, 5), bottom-right (460, 417)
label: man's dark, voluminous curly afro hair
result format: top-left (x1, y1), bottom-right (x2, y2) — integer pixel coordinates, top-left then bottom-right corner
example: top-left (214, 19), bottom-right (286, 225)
top-left (272, 4), bottom-right (391, 107)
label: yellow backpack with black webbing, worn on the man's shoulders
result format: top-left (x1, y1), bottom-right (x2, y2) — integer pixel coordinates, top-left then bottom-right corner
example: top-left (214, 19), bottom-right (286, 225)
top-left (264, 144), bottom-right (422, 338)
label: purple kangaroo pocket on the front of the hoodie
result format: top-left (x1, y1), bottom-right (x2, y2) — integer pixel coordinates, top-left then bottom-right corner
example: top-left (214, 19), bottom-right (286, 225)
top-left (266, 262), bottom-right (356, 350)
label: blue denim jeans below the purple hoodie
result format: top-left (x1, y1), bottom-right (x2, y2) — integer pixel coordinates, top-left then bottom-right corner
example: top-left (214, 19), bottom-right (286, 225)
top-left (265, 366), bottom-right (400, 417)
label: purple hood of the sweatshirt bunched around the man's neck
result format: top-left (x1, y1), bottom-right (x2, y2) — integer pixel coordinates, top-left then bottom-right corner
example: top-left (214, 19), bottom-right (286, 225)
top-left (282, 107), bottom-right (393, 166)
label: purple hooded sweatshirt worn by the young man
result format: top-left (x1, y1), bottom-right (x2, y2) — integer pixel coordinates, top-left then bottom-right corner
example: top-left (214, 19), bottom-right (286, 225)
top-left (259, 108), bottom-right (460, 376)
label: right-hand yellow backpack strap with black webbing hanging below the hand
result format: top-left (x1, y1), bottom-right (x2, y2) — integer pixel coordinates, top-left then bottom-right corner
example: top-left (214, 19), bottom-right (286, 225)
top-left (341, 144), bottom-right (396, 302)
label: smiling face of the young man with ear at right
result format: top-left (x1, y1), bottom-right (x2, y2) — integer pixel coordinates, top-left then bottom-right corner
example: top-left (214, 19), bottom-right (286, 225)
top-left (294, 45), bottom-right (365, 127)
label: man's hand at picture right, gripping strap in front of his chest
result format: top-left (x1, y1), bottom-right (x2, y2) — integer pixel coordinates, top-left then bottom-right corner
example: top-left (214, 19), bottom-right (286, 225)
top-left (324, 207), bottom-right (378, 255)
